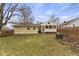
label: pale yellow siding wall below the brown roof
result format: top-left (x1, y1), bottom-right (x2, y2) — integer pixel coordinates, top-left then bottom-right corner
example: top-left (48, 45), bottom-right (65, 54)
top-left (14, 27), bottom-right (38, 34)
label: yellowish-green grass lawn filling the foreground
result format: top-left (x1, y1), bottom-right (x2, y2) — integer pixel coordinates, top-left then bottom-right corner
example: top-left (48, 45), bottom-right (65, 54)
top-left (0, 34), bottom-right (79, 56)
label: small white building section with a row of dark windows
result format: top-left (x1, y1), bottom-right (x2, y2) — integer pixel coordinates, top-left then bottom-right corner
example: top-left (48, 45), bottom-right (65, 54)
top-left (41, 22), bottom-right (57, 33)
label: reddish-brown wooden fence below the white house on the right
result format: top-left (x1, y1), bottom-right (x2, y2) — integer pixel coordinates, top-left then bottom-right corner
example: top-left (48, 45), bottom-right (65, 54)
top-left (58, 28), bottom-right (79, 43)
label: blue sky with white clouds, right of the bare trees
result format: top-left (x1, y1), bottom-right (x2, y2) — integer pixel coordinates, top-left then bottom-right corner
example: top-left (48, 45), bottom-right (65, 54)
top-left (24, 3), bottom-right (79, 22)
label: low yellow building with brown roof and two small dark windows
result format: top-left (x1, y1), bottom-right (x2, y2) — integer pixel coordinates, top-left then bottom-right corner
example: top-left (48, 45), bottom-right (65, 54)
top-left (14, 22), bottom-right (39, 34)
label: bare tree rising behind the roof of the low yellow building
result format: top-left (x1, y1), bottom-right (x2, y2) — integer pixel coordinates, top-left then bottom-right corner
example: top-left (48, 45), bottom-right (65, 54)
top-left (20, 5), bottom-right (34, 24)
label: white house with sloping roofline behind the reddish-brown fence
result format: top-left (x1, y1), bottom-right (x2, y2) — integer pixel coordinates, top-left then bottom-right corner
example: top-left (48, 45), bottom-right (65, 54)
top-left (60, 18), bottom-right (79, 27)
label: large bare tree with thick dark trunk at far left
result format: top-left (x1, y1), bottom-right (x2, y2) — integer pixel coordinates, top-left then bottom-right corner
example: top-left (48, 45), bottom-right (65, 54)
top-left (0, 3), bottom-right (18, 30)
